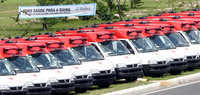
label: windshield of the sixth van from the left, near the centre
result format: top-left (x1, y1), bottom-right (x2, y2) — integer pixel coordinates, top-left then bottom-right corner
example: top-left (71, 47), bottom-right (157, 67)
top-left (98, 41), bottom-right (130, 56)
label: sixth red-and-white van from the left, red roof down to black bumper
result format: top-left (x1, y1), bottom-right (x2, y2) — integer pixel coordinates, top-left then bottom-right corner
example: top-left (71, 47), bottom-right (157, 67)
top-left (57, 31), bottom-right (142, 81)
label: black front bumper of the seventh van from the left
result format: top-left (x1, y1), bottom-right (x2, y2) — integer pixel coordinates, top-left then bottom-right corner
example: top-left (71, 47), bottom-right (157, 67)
top-left (142, 64), bottom-right (170, 75)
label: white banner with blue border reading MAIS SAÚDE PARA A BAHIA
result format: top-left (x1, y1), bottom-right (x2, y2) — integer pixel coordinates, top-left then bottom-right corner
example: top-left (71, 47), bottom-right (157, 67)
top-left (19, 3), bottom-right (96, 19)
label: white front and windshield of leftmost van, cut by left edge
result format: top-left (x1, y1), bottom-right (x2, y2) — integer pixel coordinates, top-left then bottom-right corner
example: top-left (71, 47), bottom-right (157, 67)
top-left (0, 59), bottom-right (27, 95)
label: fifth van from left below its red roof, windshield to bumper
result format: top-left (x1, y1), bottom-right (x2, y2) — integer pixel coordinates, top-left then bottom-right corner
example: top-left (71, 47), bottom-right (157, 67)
top-left (70, 45), bottom-right (116, 87)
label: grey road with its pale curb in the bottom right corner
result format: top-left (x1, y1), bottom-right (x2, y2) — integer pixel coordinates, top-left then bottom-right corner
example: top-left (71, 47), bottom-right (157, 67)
top-left (102, 73), bottom-right (200, 95)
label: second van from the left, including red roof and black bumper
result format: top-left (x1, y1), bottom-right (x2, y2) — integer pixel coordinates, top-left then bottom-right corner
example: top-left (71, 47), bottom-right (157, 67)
top-left (0, 45), bottom-right (51, 95)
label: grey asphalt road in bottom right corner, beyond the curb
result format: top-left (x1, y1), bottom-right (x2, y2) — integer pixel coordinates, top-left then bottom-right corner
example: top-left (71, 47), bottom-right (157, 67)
top-left (142, 81), bottom-right (200, 95)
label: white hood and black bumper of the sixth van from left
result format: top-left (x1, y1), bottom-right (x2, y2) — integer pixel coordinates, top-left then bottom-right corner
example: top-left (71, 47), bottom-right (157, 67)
top-left (90, 40), bottom-right (142, 80)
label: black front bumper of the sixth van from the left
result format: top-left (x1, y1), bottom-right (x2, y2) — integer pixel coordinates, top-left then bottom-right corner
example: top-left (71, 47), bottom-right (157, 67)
top-left (115, 66), bottom-right (143, 79)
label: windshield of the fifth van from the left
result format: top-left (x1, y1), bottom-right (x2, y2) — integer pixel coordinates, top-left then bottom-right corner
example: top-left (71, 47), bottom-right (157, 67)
top-left (72, 46), bottom-right (103, 61)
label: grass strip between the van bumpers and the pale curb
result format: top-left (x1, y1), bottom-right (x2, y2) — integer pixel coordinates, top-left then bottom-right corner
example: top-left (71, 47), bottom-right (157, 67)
top-left (69, 68), bottom-right (200, 95)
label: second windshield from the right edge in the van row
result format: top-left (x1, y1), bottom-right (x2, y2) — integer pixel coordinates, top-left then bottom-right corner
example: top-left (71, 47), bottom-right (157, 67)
top-left (166, 33), bottom-right (189, 47)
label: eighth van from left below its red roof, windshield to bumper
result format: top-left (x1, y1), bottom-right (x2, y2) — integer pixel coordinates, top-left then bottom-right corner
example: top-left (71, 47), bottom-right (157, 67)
top-left (148, 35), bottom-right (188, 74)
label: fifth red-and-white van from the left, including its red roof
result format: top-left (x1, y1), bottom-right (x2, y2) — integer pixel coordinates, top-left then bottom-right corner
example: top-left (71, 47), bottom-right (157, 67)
top-left (29, 34), bottom-right (116, 88)
